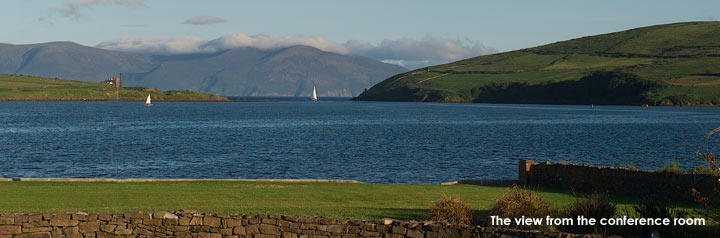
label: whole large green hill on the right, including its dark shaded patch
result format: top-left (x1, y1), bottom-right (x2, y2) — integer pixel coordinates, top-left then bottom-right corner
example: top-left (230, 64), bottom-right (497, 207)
top-left (355, 22), bottom-right (720, 105)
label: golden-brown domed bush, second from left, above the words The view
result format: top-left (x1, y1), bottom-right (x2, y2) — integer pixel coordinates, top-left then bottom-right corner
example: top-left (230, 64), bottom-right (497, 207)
top-left (488, 186), bottom-right (552, 230)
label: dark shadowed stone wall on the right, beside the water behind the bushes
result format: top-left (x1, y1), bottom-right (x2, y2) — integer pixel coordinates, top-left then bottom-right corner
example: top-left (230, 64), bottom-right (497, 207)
top-left (518, 160), bottom-right (720, 203)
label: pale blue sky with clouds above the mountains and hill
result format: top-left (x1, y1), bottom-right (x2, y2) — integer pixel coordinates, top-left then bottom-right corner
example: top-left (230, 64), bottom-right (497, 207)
top-left (5, 0), bottom-right (720, 68)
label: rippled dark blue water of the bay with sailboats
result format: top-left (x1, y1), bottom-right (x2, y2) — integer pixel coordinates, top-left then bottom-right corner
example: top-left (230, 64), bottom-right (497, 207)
top-left (0, 97), bottom-right (720, 183)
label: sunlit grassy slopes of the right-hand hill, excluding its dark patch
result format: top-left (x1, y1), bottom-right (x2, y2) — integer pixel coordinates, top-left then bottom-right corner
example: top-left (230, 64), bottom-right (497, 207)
top-left (358, 22), bottom-right (720, 105)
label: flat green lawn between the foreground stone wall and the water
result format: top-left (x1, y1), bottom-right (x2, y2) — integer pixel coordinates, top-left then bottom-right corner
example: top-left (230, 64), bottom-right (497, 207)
top-left (0, 181), bottom-right (698, 222)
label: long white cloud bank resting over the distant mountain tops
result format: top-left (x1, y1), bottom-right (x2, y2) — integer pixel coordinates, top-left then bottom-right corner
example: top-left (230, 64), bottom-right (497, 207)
top-left (97, 33), bottom-right (497, 69)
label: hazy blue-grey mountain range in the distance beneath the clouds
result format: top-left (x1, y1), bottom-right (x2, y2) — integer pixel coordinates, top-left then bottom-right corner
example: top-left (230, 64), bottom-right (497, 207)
top-left (0, 42), bottom-right (406, 96)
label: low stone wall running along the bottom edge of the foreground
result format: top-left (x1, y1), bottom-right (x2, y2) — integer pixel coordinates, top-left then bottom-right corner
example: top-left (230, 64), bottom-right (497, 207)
top-left (0, 211), bottom-right (590, 238)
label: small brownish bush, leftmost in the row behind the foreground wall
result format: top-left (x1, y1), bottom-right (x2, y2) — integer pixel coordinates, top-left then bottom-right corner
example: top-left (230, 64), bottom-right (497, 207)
top-left (430, 196), bottom-right (472, 225)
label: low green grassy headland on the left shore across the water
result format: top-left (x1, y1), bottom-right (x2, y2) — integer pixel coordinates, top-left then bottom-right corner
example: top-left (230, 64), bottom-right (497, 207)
top-left (0, 75), bottom-right (227, 101)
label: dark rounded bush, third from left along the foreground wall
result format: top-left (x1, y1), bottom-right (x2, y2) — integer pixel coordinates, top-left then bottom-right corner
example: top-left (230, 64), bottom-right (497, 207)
top-left (560, 193), bottom-right (617, 233)
